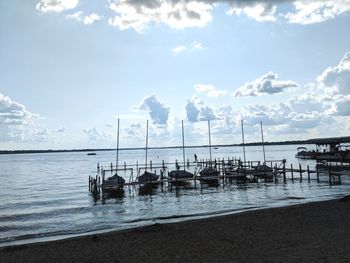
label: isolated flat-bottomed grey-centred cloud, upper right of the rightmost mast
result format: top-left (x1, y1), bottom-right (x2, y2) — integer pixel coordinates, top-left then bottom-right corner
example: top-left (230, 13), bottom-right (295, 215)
top-left (233, 72), bottom-right (298, 97)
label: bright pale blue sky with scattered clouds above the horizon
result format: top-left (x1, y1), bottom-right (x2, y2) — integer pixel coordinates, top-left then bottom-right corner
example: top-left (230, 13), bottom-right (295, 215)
top-left (0, 0), bottom-right (350, 150)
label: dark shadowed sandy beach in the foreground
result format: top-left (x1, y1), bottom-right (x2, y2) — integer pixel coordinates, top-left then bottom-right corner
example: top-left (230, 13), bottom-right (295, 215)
top-left (0, 197), bottom-right (350, 263)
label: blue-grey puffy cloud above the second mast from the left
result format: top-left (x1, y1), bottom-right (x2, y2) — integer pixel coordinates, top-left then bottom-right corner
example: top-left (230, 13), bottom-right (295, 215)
top-left (133, 95), bottom-right (170, 124)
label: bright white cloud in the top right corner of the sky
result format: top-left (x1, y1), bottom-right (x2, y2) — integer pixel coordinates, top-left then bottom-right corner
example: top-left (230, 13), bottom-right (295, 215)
top-left (285, 0), bottom-right (350, 25)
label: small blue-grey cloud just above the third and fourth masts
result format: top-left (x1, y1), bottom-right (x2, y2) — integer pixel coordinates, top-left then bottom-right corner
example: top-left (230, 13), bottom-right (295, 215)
top-left (186, 96), bottom-right (218, 122)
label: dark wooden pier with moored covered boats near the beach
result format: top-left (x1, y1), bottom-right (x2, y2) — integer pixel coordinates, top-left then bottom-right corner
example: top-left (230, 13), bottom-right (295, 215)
top-left (89, 157), bottom-right (344, 194)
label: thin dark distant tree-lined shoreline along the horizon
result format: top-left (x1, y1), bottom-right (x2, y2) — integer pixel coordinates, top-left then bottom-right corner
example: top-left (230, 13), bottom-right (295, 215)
top-left (0, 136), bottom-right (350, 154)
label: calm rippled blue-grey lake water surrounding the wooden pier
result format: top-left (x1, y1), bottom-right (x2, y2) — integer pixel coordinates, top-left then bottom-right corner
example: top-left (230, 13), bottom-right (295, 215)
top-left (0, 146), bottom-right (350, 246)
